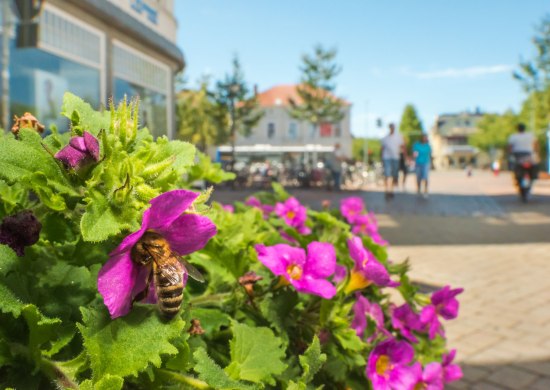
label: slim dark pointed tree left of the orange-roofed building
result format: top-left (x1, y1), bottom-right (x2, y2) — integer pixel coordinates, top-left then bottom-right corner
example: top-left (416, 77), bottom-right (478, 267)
top-left (214, 56), bottom-right (264, 162)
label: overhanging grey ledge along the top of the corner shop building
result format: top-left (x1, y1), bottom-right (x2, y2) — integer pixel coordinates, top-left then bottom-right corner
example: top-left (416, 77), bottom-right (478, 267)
top-left (64, 0), bottom-right (185, 71)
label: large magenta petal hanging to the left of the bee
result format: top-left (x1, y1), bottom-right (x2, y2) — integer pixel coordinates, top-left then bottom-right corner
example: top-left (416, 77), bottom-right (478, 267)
top-left (97, 252), bottom-right (142, 318)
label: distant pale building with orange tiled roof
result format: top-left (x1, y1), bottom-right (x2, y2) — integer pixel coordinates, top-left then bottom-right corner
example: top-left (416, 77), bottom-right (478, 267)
top-left (220, 85), bottom-right (352, 162)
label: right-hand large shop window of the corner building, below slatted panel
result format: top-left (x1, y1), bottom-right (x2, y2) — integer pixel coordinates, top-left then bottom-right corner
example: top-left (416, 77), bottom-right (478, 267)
top-left (115, 79), bottom-right (168, 138)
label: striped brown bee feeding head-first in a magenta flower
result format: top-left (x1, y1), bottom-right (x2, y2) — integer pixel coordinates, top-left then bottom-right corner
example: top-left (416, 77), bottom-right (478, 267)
top-left (131, 230), bottom-right (204, 319)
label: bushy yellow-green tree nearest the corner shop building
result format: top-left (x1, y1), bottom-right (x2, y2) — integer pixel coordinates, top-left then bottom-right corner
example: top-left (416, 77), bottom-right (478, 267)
top-left (176, 81), bottom-right (224, 152)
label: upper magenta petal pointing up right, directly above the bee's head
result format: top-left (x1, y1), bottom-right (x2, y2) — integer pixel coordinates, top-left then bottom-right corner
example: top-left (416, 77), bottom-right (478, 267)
top-left (146, 190), bottom-right (199, 230)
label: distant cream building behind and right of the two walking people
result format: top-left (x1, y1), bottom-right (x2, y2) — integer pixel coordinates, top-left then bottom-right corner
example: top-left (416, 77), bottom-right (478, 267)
top-left (430, 110), bottom-right (483, 169)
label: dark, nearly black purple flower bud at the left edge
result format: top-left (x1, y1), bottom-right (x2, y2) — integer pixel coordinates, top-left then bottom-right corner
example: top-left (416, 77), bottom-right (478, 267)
top-left (0, 210), bottom-right (42, 256)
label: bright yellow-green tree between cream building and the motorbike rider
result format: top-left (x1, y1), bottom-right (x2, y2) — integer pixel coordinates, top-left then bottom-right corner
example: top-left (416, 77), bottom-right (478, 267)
top-left (468, 110), bottom-right (519, 152)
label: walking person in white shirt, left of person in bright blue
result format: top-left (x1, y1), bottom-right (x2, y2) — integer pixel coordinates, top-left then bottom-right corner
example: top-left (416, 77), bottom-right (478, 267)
top-left (382, 123), bottom-right (407, 199)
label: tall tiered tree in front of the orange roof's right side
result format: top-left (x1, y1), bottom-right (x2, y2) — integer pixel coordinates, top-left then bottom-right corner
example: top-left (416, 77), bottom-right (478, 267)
top-left (289, 45), bottom-right (345, 133)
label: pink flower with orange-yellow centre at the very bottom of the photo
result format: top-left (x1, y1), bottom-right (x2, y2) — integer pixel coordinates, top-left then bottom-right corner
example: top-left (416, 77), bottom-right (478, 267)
top-left (366, 339), bottom-right (418, 390)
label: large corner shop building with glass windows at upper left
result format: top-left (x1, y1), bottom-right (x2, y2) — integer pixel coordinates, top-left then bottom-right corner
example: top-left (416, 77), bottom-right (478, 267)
top-left (0, 0), bottom-right (184, 136)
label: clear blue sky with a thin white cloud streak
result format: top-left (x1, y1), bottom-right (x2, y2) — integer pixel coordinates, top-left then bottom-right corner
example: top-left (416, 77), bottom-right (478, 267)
top-left (174, 0), bottom-right (550, 136)
